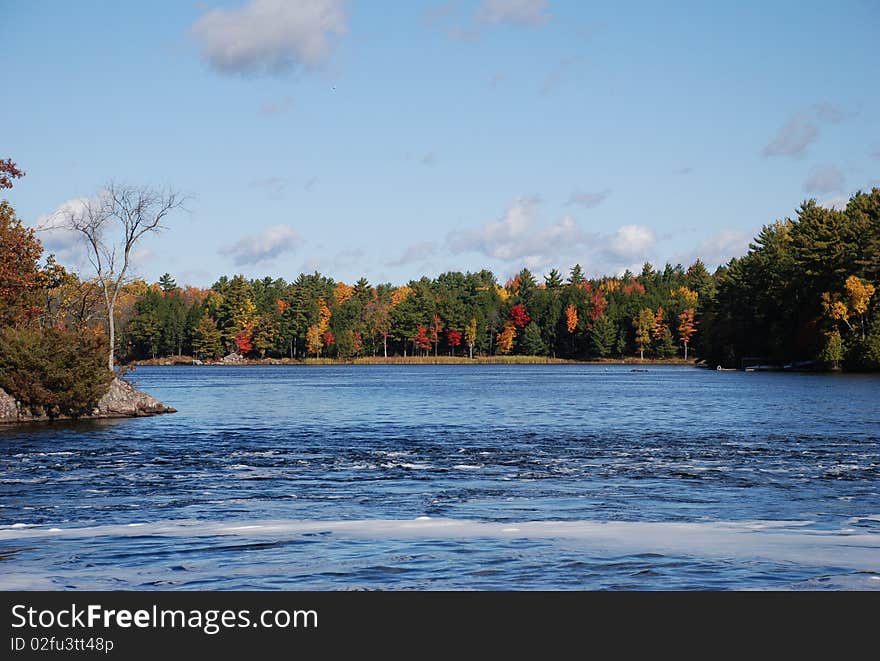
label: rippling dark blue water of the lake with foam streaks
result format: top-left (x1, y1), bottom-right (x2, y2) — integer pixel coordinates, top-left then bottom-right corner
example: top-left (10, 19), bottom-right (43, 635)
top-left (0, 365), bottom-right (880, 589)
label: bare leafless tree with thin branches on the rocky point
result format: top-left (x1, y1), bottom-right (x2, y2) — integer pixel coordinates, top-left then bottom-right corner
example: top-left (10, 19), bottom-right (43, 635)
top-left (61, 181), bottom-right (187, 370)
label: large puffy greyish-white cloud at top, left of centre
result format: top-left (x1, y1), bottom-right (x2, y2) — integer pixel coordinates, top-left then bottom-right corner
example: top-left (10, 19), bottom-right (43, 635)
top-left (191, 0), bottom-right (347, 73)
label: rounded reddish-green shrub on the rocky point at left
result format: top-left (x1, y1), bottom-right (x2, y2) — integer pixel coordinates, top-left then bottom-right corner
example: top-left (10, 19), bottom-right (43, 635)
top-left (0, 326), bottom-right (114, 418)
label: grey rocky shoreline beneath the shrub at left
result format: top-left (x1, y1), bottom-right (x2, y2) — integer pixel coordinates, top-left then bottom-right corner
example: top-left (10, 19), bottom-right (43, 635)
top-left (0, 378), bottom-right (177, 425)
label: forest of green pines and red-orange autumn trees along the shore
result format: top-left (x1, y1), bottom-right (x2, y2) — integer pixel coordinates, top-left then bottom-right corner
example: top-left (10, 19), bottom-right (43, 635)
top-left (0, 150), bottom-right (880, 412)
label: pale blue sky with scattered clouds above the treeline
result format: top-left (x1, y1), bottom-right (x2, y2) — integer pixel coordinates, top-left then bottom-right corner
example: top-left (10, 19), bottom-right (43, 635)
top-left (0, 0), bottom-right (880, 287)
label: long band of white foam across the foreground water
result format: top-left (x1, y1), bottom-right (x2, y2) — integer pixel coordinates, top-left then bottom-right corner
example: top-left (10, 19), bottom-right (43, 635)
top-left (0, 516), bottom-right (880, 572)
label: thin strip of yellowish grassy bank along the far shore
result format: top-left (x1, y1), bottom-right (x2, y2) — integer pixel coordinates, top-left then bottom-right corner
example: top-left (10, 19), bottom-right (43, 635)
top-left (131, 356), bottom-right (696, 367)
